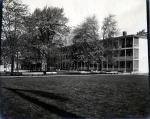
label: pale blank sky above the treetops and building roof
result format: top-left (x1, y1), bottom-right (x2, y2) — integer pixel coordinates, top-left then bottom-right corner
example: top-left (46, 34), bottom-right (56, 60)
top-left (22, 0), bottom-right (146, 34)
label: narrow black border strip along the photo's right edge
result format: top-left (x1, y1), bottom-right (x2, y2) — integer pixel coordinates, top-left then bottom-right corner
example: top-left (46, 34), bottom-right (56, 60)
top-left (146, 0), bottom-right (150, 93)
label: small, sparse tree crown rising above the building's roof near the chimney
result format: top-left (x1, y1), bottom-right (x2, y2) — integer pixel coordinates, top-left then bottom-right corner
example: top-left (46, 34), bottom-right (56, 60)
top-left (101, 14), bottom-right (119, 39)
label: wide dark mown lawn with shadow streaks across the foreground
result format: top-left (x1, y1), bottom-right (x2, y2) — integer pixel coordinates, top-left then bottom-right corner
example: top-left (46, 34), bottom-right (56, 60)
top-left (1, 75), bottom-right (149, 119)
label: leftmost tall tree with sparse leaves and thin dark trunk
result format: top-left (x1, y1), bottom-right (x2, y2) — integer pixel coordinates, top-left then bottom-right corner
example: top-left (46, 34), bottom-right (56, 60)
top-left (2, 0), bottom-right (28, 74)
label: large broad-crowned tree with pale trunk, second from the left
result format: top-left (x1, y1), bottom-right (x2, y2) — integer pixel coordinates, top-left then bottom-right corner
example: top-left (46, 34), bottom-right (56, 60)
top-left (22, 7), bottom-right (69, 71)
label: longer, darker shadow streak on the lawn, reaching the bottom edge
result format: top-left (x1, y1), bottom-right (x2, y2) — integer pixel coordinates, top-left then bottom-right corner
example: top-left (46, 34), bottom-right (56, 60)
top-left (5, 88), bottom-right (84, 119)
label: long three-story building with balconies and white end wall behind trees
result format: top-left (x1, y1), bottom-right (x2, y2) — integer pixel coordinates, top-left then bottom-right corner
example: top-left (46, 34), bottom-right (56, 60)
top-left (1, 33), bottom-right (149, 73)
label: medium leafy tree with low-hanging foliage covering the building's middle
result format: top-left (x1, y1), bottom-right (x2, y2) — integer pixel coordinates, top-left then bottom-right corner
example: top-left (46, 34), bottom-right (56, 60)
top-left (72, 16), bottom-right (103, 69)
